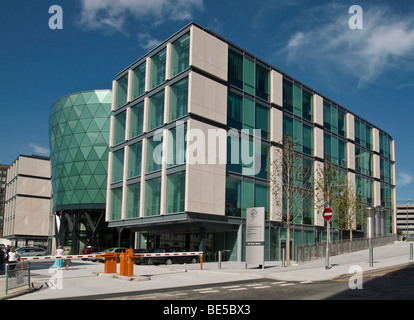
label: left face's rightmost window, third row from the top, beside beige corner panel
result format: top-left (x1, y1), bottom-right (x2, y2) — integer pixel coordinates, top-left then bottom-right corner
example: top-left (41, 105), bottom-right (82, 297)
top-left (168, 123), bottom-right (187, 167)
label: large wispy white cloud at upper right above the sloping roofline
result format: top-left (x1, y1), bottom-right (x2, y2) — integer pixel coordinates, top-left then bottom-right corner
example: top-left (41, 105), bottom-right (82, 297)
top-left (279, 3), bottom-right (414, 87)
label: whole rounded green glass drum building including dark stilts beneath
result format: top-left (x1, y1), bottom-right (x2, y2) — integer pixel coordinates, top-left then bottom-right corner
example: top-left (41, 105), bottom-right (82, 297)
top-left (49, 90), bottom-right (129, 253)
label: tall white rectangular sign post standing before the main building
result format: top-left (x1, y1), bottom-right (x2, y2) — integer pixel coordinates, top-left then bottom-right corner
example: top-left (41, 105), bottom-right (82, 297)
top-left (246, 207), bottom-right (265, 269)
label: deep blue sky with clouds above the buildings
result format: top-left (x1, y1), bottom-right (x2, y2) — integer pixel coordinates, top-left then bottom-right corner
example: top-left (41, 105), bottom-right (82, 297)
top-left (0, 0), bottom-right (414, 202)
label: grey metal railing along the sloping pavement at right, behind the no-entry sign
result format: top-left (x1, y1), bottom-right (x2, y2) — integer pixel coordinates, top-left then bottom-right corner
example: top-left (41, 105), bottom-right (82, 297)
top-left (296, 234), bottom-right (397, 262)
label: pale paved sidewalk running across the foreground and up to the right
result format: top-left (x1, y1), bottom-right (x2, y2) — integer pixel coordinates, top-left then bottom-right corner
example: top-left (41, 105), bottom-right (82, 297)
top-left (0, 241), bottom-right (414, 300)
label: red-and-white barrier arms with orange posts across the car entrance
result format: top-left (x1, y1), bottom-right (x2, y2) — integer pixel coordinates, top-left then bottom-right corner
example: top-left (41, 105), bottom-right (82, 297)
top-left (20, 249), bottom-right (203, 277)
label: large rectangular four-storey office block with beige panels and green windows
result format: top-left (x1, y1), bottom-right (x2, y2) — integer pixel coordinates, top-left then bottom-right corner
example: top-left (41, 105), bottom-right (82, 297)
top-left (106, 23), bottom-right (396, 261)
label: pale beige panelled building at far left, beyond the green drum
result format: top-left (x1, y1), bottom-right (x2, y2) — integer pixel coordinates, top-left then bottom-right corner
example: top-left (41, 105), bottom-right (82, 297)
top-left (3, 155), bottom-right (52, 247)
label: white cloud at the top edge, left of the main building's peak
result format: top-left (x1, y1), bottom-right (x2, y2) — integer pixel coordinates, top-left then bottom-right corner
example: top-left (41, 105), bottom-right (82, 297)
top-left (79, 0), bottom-right (203, 32)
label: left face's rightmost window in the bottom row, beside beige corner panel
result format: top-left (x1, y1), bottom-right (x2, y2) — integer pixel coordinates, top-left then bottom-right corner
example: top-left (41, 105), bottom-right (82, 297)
top-left (166, 171), bottom-right (185, 213)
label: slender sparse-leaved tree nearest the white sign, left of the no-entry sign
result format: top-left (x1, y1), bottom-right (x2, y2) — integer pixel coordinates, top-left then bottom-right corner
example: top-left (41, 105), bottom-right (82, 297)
top-left (270, 135), bottom-right (313, 265)
